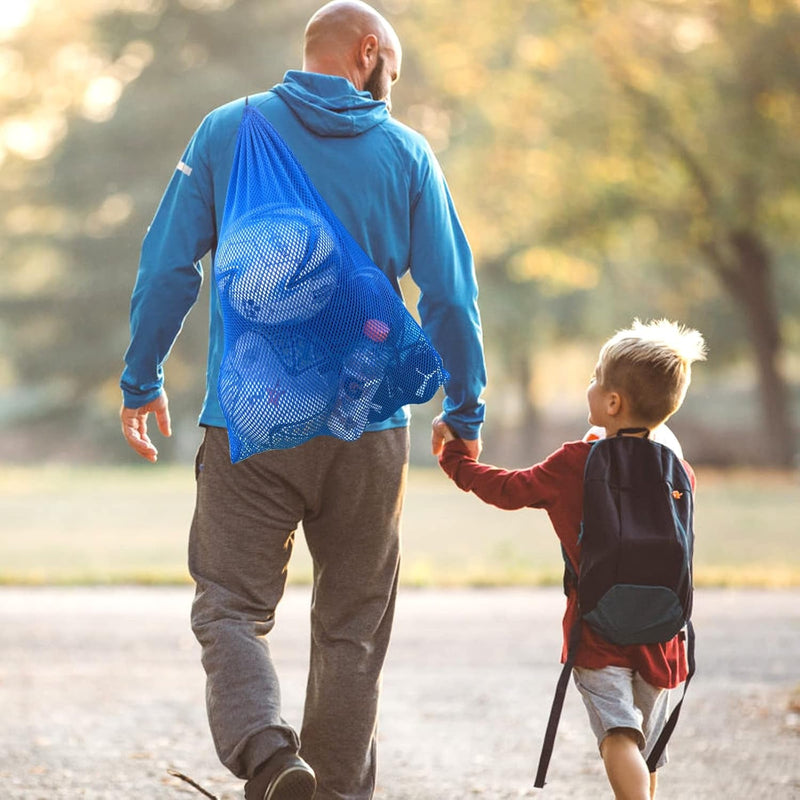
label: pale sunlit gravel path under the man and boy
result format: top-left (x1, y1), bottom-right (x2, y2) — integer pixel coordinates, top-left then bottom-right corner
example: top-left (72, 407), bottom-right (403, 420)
top-left (0, 588), bottom-right (800, 800)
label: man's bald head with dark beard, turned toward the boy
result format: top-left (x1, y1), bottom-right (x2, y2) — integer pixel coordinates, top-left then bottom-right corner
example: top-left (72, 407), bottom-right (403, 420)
top-left (303, 0), bottom-right (402, 107)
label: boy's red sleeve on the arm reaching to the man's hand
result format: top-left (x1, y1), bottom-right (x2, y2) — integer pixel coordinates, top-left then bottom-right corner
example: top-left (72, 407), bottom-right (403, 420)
top-left (439, 439), bottom-right (561, 510)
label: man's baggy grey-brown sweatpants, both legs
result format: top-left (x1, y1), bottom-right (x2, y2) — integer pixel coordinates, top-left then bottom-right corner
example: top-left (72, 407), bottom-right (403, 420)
top-left (189, 428), bottom-right (409, 800)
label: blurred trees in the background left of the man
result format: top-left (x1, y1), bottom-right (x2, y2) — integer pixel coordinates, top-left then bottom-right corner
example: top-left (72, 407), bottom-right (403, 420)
top-left (0, 0), bottom-right (315, 457)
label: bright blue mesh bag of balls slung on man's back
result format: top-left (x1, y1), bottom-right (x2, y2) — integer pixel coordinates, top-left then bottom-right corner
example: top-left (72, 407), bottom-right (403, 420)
top-left (214, 104), bottom-right (448, 463)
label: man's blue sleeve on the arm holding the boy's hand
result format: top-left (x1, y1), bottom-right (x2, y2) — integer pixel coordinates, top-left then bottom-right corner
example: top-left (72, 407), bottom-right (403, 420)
top-left (410, 153), bottom-right (486, 439)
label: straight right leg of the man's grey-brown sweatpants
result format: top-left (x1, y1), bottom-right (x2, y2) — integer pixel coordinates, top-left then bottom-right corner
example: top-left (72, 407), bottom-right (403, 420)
top-left (301, 428), bottom-right (408, 800)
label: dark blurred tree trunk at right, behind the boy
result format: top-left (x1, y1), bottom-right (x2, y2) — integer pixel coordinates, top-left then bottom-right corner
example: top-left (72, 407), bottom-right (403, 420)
top-left (712, 230), bottom-right (795, 467)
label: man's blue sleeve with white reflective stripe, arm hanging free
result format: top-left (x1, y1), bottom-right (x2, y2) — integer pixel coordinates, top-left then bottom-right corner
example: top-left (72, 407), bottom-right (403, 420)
top-left (120, 123), bottom-right (216, 408)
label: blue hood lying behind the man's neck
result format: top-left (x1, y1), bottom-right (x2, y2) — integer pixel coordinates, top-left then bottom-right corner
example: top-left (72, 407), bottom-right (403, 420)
top-left (272, 70), bottom-right (389, 136)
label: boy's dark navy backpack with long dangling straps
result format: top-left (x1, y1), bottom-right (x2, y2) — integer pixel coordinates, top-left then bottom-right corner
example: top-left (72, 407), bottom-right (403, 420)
top-left (534, 428), bottom-right (695, 788)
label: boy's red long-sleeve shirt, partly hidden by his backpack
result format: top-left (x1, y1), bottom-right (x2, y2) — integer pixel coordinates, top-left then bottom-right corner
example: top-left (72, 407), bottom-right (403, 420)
top-left (439, 439), bottom-right (695, 689)
